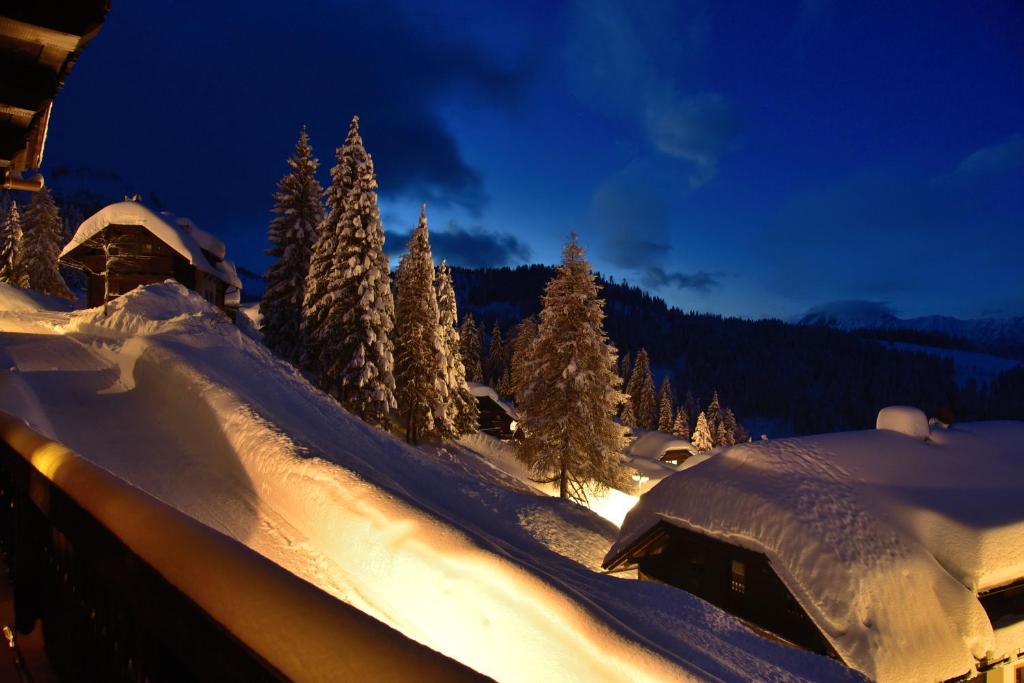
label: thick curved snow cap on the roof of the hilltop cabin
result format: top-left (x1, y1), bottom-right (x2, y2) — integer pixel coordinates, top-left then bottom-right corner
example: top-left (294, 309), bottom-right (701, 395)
top-left (60, 202), bottom-right (242, 289)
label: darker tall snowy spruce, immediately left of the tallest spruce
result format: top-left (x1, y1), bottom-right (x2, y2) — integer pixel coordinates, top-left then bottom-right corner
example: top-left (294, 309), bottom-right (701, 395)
top-left (260, 126), bottom-right (324, 362)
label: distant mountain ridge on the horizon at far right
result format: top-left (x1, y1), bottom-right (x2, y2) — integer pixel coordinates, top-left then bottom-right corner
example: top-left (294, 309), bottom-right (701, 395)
top-left (799, 301), bottom-right (1024, 358)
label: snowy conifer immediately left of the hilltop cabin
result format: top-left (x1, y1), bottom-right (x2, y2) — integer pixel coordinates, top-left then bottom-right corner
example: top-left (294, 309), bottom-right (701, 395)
top-left (19, 187), bottom-right (75, 299)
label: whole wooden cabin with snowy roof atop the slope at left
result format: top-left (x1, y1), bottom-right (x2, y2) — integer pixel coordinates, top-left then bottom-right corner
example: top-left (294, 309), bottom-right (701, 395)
top-left (60, 201), bottom-right (242, 314)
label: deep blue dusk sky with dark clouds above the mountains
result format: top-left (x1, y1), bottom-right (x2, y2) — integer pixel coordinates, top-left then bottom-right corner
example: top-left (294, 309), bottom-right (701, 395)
top-left (44, 0), bottom-right (1024, 317)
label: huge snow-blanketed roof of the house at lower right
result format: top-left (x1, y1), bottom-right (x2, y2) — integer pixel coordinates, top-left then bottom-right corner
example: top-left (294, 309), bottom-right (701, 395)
top-left (605, 411), bottom-right (1024, 681)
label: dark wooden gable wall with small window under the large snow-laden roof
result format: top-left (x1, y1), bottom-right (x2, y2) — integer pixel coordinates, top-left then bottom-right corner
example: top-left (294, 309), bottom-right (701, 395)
top-left (612, 522), bottom-right (840, 659)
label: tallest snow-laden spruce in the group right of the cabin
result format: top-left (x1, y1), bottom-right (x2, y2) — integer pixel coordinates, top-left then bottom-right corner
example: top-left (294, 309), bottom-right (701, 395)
top-left (303, 117), bottom-right (395, 424)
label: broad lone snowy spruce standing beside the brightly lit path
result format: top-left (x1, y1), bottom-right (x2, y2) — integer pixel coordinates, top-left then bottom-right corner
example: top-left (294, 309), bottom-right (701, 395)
top-left (516, 233), bottom-right (626, 502)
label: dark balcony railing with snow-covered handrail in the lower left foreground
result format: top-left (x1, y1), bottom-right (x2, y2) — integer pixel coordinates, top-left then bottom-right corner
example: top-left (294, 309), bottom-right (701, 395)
top-left (0, 413), bottom-right (483, 681)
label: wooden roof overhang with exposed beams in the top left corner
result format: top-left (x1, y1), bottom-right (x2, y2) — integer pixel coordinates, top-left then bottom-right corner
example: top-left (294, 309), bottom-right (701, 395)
top-left (0, 0), bottom-right (110, 190)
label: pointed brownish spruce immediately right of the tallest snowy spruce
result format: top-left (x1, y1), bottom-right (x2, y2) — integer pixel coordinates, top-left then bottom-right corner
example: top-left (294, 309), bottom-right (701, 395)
top-left (394, 205), bottom-right (446, 443)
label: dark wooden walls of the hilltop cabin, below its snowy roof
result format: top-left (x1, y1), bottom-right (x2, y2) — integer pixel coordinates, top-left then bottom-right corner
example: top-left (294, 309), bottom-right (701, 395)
top-left (62, 225), bottom-right (227, 308)
